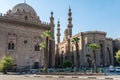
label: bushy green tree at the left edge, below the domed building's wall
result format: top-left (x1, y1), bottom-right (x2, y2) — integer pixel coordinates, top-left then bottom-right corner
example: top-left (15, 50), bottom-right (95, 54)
top-left (0, 56), bottom-right (14, 74)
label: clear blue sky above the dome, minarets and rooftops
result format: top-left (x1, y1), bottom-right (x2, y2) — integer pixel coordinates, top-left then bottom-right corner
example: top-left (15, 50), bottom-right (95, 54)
top-left (0, 0), bottom-right (120, 41)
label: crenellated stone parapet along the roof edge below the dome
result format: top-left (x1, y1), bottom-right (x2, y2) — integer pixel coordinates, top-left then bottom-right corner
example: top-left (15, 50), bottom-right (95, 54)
top-left (0, 13), bottom-right (50, 29)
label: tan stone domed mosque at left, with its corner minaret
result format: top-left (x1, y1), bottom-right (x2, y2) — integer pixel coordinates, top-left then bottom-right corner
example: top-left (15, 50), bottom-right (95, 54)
top-left (0, 3), bottom-right (55, 68)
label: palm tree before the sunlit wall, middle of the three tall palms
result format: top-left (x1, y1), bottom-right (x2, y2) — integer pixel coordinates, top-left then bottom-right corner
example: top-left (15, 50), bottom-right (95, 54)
top-left (72, 37), bottom-right (80, 68)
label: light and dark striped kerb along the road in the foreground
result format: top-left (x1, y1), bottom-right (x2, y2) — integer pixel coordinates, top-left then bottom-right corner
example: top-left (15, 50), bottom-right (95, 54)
top-left (25, 75), bottom-right (120, 80)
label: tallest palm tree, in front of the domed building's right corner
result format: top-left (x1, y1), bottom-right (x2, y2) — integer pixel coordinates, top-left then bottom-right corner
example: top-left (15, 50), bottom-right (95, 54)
top-left (41, 31), bottom-right (53, 72)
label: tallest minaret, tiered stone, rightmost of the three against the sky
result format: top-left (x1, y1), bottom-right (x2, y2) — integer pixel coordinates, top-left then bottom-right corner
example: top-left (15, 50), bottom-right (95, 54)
top-left (67, 8), bottom-right (73, 38)
